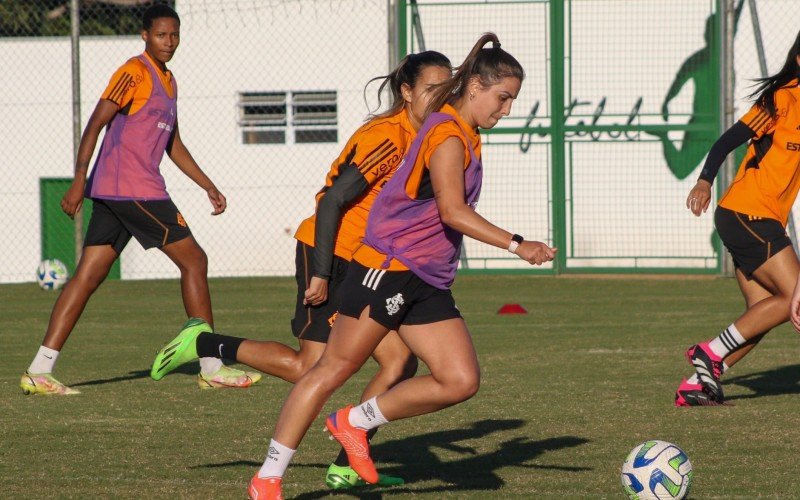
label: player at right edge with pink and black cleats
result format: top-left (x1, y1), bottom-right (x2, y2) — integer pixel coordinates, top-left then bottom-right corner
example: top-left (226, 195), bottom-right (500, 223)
top-left (675, 29), bottom-right (800, 406)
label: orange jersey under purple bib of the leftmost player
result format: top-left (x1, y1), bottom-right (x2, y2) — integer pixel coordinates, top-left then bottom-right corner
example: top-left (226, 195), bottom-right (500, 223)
top-left (102, 52), bottom-right (175, 115)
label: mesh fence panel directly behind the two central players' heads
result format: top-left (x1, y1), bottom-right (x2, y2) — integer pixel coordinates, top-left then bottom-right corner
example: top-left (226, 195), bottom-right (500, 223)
top-left (408, 1), bottom-right (553, 270)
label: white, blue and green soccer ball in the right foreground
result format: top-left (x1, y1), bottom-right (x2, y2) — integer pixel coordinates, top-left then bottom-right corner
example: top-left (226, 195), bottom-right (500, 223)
top-left (620, 440), bottom-right (693, 500)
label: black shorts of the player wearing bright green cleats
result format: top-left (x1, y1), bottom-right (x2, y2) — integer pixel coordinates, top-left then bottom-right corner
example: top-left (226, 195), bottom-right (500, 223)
top-left (292, 241), bottom-right (349, 343)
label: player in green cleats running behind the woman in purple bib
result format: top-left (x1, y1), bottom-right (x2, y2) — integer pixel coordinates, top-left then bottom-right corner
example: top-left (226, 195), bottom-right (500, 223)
top-left (151, 51), bottom-right (452, 489)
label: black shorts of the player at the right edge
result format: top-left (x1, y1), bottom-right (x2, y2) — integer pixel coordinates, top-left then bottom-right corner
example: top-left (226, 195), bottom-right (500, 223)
top-left (714, 207), bottom-right (792, 278)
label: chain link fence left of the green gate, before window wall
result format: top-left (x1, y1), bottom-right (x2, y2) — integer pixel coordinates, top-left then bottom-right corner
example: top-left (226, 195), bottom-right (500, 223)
top-left (0, 0), bottom-right (389, 282)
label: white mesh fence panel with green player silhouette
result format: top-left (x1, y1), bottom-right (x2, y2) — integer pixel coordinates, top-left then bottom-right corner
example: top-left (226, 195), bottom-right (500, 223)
top-left (566, 0), bottom-right (719, 268)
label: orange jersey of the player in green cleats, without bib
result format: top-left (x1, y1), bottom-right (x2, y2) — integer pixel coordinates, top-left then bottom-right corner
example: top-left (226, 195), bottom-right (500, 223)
top-left (294, 110), bottom-right (416, 260)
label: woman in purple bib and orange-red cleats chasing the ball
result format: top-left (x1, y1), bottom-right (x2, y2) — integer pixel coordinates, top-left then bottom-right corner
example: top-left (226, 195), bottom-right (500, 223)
top-left (249, 33), bottom-right (556, 500)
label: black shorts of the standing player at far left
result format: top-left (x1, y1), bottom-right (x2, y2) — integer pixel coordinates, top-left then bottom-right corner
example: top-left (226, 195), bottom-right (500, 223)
top-left (83, 198), bottom-right (192, 254)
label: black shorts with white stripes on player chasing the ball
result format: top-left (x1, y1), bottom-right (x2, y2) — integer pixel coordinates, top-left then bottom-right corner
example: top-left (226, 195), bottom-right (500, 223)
top-left (339, 261), bottom-right (461, 330)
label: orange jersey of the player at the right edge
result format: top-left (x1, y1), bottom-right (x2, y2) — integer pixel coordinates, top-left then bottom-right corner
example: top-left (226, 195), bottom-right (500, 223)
top-left (719, 80), bottom-right (800, 226)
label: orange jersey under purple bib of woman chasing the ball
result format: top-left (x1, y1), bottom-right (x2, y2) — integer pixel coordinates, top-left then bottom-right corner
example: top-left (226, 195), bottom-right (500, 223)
top-left (353, 104), bottom-right (481, 271)
